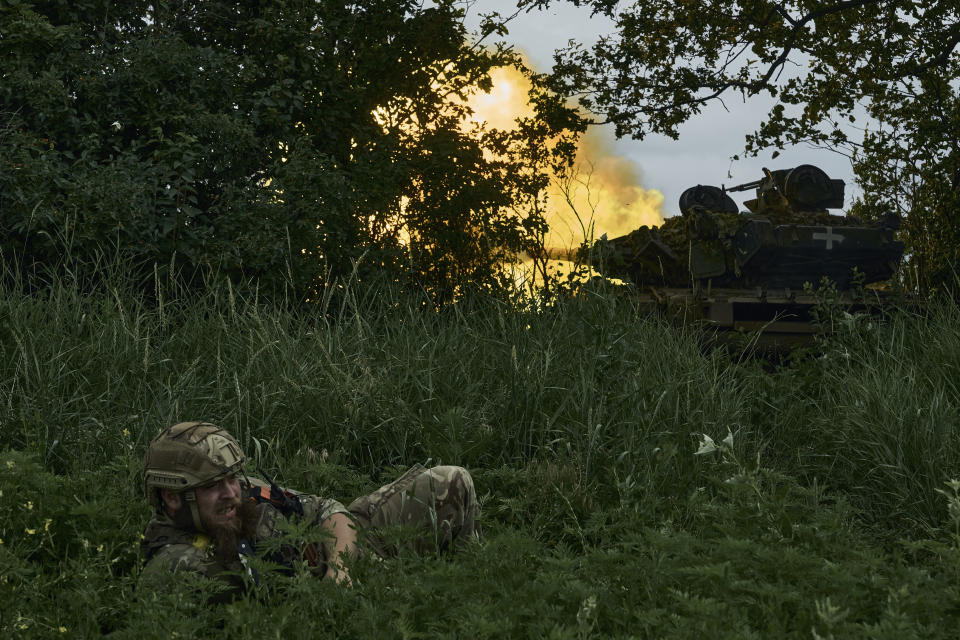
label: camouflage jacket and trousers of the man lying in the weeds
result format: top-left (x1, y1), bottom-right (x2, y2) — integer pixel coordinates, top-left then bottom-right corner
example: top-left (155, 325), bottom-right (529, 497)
top-left (140, 464), bottom-right (478, 598)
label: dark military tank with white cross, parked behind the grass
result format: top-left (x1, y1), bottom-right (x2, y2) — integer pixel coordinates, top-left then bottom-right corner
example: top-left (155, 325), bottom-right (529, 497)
top-left (587, 164), bottom-right (903, 346)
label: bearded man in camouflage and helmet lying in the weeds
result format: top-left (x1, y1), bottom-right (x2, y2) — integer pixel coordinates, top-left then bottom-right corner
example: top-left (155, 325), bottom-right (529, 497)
top-left (140, 422), bottom-right (478, 598)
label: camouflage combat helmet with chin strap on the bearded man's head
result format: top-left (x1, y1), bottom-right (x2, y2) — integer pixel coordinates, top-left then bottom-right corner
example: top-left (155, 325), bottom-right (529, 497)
top-left (143, 422), bottom-right (245, 531)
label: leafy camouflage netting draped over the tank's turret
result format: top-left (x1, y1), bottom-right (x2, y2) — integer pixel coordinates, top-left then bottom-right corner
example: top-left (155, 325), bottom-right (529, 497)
top-left (587, 207), bottom-right (863, 287)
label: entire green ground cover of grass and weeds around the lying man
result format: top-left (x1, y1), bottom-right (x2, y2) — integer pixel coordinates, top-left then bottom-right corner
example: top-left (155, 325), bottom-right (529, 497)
top-left (0, 268), bottom-right (960, 637)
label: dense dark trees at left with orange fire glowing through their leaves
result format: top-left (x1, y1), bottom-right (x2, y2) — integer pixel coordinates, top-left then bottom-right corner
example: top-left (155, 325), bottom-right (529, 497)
top-left (0, 0), bottom-right (578, 302)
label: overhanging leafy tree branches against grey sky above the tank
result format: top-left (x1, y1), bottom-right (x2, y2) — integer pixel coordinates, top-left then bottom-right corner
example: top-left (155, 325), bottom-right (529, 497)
top-left (524, 0), bottom-right (960, 296)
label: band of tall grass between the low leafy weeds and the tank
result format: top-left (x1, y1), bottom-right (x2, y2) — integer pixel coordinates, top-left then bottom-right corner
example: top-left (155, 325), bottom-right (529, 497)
top-left (9, 276), bottom-right (960, 526)
